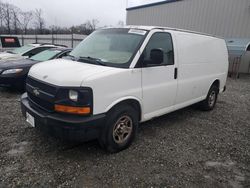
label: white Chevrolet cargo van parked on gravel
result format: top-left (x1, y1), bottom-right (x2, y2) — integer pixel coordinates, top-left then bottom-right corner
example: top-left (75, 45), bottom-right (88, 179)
top-left (21, 26), bottom-right (228, 152)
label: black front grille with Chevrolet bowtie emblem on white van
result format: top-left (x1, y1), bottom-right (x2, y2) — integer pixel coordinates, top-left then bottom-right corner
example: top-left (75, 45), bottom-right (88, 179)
top-left (26, 77), bottom-right (57, 112)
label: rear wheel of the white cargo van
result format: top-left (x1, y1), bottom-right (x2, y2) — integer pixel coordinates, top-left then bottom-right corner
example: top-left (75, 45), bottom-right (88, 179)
top-left (200, 85), bottom-right (219, 111)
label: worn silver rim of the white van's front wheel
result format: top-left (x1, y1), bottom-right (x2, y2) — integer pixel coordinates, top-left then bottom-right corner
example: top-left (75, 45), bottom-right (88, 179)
top-left (113, 116), bottom-right (133, 144)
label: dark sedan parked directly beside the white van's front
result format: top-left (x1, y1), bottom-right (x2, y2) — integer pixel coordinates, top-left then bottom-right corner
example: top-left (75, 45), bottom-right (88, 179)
top-left (0, 48), bottom-right (72, 90)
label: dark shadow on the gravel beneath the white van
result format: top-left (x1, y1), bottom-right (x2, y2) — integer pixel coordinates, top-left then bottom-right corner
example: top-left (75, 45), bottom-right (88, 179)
top-left (25, 105), bottom-right (200, 158)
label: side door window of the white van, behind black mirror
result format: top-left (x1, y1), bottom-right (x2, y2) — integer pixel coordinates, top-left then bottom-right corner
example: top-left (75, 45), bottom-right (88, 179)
top-left (142, 32), bottom-right (174, 67)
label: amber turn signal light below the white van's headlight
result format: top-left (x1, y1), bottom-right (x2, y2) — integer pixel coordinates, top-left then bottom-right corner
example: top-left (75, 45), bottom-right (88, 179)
top-left (55, 104), bottom-right (91, 115)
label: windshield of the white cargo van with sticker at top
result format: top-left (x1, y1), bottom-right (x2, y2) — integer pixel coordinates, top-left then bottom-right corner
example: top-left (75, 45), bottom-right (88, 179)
top-left (70, 28), bottom-right (147, 68)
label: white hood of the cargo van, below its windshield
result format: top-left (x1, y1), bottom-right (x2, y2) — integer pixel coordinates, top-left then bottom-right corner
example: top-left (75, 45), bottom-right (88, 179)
top-left (29, 59), bottom-right (117, 87)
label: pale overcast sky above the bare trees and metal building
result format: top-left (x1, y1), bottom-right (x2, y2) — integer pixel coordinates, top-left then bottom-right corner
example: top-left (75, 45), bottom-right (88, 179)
top-left (6, 0), bottom-right (162, 27)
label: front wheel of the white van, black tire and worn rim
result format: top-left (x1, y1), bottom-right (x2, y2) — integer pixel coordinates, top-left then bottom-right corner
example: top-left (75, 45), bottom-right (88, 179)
top-left (99, 105), bottom-right (139, 153)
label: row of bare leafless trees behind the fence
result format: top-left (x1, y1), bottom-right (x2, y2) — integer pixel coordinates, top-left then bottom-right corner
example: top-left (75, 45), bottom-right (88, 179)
top-left (0, 0), bottom-right (118, 35)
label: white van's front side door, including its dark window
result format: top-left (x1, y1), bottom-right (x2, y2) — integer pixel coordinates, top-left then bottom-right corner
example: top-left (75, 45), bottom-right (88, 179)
top-left (141, 32), bottom-right (177, 120)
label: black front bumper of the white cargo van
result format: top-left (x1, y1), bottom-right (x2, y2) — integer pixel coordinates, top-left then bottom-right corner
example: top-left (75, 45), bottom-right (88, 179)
top-left (21, 93), bottom-right (106, 141)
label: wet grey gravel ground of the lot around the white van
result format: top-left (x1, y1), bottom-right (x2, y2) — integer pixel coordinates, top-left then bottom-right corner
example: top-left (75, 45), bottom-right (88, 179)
top-left (0, 76), bottom-right (250, 188)
